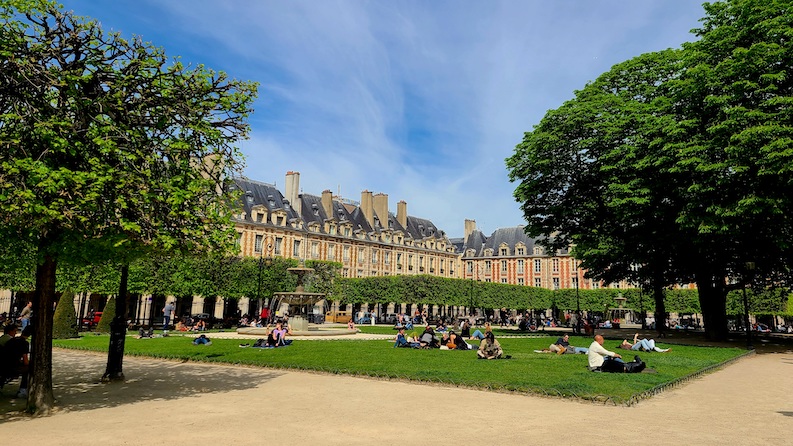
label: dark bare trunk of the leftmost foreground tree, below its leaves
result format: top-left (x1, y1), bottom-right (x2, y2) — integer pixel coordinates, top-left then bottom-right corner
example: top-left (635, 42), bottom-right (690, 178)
top-left (27, 247), bottom-right (58, 415)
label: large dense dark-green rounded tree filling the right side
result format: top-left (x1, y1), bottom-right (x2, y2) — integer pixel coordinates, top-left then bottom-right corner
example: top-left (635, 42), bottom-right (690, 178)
top-left (507, 0), bottom-right (793, 337)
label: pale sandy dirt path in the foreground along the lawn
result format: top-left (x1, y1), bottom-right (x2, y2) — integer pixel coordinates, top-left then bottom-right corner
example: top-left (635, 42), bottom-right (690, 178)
top-left (0, 350), bottom-right (793, 446)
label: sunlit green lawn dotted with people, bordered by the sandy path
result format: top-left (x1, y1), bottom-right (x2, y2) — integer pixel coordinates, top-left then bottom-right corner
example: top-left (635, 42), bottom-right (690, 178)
top-left (53, 334), bottom-right (744, 404)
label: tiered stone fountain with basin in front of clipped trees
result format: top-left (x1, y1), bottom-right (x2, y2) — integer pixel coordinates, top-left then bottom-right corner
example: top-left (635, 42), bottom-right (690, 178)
top-left (237, 262), bottom-right (355, 336)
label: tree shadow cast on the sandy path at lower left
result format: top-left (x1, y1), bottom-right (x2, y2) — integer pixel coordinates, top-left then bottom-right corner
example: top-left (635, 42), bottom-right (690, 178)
top-left (0, 350), bottom-right (284, 423)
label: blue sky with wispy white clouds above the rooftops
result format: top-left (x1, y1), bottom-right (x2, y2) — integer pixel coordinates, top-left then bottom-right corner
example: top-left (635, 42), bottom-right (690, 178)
top-left (64, 0), bottom-right (704, 237)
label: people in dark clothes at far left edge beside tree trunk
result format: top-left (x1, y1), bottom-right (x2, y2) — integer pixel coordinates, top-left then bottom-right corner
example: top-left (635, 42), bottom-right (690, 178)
top-left (0, 322), bottom-right (33, 398)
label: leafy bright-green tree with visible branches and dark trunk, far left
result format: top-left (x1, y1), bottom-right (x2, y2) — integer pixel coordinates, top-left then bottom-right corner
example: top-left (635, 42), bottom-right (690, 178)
top-left (0, 0), bottom-right (256, 413)
